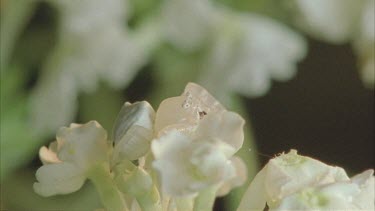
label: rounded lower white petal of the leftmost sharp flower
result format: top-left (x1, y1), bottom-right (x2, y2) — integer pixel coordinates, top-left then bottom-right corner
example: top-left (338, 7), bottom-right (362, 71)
top-left (34, 163), bottom-right (86, 197)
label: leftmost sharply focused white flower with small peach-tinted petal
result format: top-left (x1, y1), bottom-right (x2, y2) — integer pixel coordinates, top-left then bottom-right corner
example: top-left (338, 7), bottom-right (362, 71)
top-left (34, 121), bottom-right (109, 196)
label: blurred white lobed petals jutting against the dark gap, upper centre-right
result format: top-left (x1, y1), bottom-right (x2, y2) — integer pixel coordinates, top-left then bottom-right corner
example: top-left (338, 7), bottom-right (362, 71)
top-left (227, 14), bottom-right (307, 96)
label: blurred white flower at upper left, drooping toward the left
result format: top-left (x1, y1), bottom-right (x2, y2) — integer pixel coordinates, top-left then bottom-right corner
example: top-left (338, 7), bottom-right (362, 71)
top-left (31, 0), bottom-right (148, 135)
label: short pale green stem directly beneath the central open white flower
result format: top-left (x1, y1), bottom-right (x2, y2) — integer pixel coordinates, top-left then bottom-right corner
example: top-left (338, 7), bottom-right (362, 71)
top-left (193, 186), bottom-right (218, 211)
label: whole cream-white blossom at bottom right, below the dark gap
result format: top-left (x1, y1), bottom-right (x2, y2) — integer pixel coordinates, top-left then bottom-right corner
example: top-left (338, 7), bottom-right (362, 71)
top-left (238, 150), bottom-right (374, 211)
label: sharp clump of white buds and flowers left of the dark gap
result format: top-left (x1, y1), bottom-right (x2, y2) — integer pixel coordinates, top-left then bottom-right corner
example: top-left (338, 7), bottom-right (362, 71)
top-left (34, 83), bottom-right (246, 211)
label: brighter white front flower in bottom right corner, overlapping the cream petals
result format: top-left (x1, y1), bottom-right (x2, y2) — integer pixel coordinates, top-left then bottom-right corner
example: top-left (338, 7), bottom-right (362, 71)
top-left (272, 170), bottom-right (375, 210)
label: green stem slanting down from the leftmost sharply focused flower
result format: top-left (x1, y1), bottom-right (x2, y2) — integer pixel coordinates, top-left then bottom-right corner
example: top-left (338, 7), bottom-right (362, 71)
top-left (89, 164), bottom-right (128, 211)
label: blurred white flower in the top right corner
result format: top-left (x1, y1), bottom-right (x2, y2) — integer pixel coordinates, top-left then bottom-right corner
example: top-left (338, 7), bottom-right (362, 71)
top-left (292, 0), bottom-right (375, 89)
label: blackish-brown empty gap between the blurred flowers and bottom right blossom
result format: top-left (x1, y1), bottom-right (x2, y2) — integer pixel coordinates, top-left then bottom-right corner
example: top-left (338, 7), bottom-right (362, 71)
top-left (246, 39), bottom-right (374, 175)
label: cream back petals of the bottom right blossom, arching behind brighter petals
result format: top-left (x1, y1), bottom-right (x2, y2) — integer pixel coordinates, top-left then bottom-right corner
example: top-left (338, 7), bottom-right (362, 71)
top-left (239, 150), bottom-right (356, 211)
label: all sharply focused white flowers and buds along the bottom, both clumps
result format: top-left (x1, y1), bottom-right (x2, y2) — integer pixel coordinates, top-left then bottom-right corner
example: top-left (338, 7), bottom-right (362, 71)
top-left (34, 83), bottom-right (374, 211)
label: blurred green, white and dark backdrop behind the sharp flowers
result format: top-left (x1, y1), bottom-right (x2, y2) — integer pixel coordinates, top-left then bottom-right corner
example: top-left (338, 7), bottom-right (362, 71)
top-left (0, 0), bottom-right (375, 211)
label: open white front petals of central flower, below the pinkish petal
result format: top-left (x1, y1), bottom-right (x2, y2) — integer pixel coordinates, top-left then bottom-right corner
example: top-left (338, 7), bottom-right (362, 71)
top-left (151, 131), bottom-right (235, 196)
